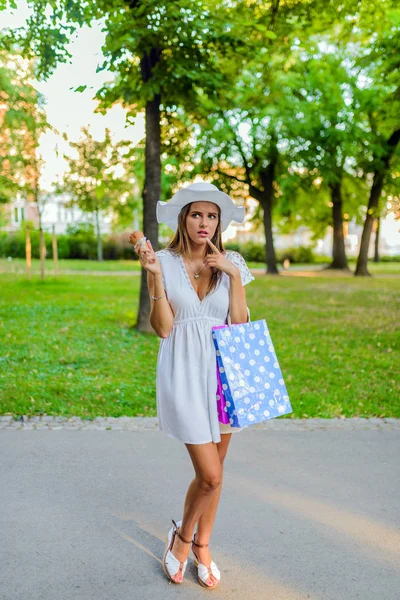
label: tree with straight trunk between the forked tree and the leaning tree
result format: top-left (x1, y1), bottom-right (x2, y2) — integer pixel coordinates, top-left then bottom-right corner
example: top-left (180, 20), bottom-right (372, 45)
top-left (272, 49), bottom-right (364, 270)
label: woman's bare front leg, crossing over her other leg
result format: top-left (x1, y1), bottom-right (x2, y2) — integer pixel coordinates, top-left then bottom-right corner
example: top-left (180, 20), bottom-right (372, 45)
top-left (166, 442), bottom-right (222, 581)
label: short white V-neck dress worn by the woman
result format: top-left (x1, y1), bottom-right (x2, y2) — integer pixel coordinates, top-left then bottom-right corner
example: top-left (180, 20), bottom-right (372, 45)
top-left (156, 249), bottom-right (254, 444)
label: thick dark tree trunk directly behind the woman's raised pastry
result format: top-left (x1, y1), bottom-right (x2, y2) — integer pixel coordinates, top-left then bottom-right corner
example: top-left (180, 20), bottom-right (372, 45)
top-left (136, 94), bottom-right (161, 333)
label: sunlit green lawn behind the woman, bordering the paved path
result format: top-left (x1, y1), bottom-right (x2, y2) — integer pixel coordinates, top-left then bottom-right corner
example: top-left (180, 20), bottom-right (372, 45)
top-left (0, 265), bottom-right (400, 418)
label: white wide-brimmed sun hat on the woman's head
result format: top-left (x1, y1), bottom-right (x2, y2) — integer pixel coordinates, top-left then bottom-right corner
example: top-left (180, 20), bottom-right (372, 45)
top-left (156, 181), bottom-right (246, 231)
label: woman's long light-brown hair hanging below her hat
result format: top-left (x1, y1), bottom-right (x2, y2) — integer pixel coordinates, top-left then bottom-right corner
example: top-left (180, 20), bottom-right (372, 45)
top-left (166, 202), bottom-right (225, 297)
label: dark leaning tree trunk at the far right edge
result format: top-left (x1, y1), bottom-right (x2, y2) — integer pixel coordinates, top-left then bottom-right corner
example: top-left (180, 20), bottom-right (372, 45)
top-left (354, 129), bottom-right (400, 276)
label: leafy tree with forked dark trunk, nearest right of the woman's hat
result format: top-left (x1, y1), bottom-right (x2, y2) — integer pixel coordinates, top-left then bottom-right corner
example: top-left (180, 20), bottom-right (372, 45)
top-left (191, 0), bottom-right (366, 274)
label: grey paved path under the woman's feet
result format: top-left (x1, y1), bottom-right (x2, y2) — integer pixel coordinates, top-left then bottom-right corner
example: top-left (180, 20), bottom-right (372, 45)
top-left (0, 419), bottom-right (400, 600)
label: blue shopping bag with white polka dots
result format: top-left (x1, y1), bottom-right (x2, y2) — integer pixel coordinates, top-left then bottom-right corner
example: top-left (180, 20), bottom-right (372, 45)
top-left (212, 319), bottom-right (293, 427)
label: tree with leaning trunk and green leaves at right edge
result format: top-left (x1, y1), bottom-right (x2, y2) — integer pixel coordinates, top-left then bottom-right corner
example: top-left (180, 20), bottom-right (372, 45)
top-left (355, 2), bottom-right (400, 276)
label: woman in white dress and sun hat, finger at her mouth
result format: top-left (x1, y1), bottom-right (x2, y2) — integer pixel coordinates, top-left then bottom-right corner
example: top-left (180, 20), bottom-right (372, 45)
top-left (139, 182), bottom-right (254, 588)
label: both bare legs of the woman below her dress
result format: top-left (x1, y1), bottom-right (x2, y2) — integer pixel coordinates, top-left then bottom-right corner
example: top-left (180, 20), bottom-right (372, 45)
top-left (168, 433), bottom-right (232, 585)
